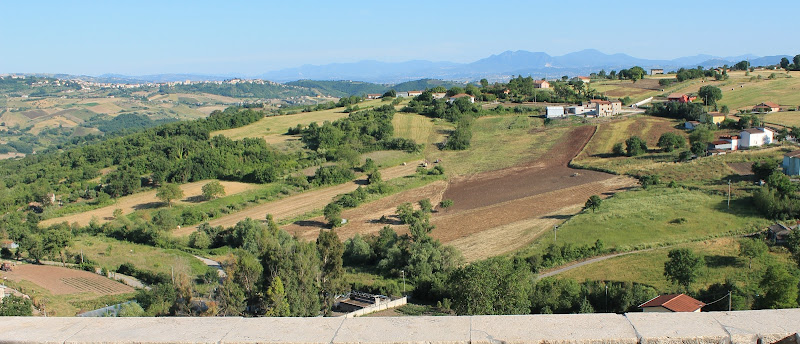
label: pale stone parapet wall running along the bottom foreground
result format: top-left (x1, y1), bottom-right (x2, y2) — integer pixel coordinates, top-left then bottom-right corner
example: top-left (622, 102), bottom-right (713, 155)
top-left (0, 309), bottom-right (800, 344)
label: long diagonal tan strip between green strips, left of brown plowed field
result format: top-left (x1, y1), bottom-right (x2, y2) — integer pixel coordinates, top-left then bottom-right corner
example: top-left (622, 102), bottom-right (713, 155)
top-left (173, 161), bottom-right (420, 236)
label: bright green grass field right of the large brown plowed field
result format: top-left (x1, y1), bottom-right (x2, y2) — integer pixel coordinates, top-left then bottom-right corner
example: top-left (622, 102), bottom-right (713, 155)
top-left (520, 187), bottom-right (770, 252)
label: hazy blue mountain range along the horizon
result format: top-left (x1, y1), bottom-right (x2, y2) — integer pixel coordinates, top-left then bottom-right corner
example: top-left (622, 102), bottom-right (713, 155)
top-left (25, 49), bottom-right (792, 84)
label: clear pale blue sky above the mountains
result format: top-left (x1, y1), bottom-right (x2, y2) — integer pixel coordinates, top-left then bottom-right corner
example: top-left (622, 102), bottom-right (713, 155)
top-left (0, 0), bottom-right (800, 75)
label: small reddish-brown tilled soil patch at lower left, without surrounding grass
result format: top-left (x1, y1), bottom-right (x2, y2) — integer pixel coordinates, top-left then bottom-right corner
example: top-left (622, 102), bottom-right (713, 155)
top-left (0, 264), bottom-right (135, 295)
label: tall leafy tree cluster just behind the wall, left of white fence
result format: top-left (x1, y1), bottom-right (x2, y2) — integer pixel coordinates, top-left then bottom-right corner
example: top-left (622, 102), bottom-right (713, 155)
top-left (136, 217), bottom-right (346, 316)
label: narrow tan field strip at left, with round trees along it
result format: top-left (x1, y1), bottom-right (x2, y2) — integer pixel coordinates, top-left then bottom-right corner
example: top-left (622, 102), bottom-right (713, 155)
top-left (40, 180), bottom-right (255, 226)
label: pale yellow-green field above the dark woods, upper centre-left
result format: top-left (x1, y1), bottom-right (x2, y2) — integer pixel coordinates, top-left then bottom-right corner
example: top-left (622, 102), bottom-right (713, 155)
top-left (211, 99), bottom-right (382, 144)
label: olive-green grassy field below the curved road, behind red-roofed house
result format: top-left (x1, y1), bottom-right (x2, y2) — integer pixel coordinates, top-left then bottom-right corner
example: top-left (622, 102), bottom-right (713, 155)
top-left (558, 238), bottom-right (791, 296)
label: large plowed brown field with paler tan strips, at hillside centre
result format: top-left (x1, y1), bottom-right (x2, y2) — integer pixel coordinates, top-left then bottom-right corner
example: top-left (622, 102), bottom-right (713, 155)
top-left (284, 126), bottom-right (636, 261)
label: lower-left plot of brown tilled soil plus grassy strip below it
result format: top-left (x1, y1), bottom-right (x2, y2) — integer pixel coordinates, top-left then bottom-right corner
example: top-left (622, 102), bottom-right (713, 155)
top-left (0, 264), bottom-right (134, 316)
